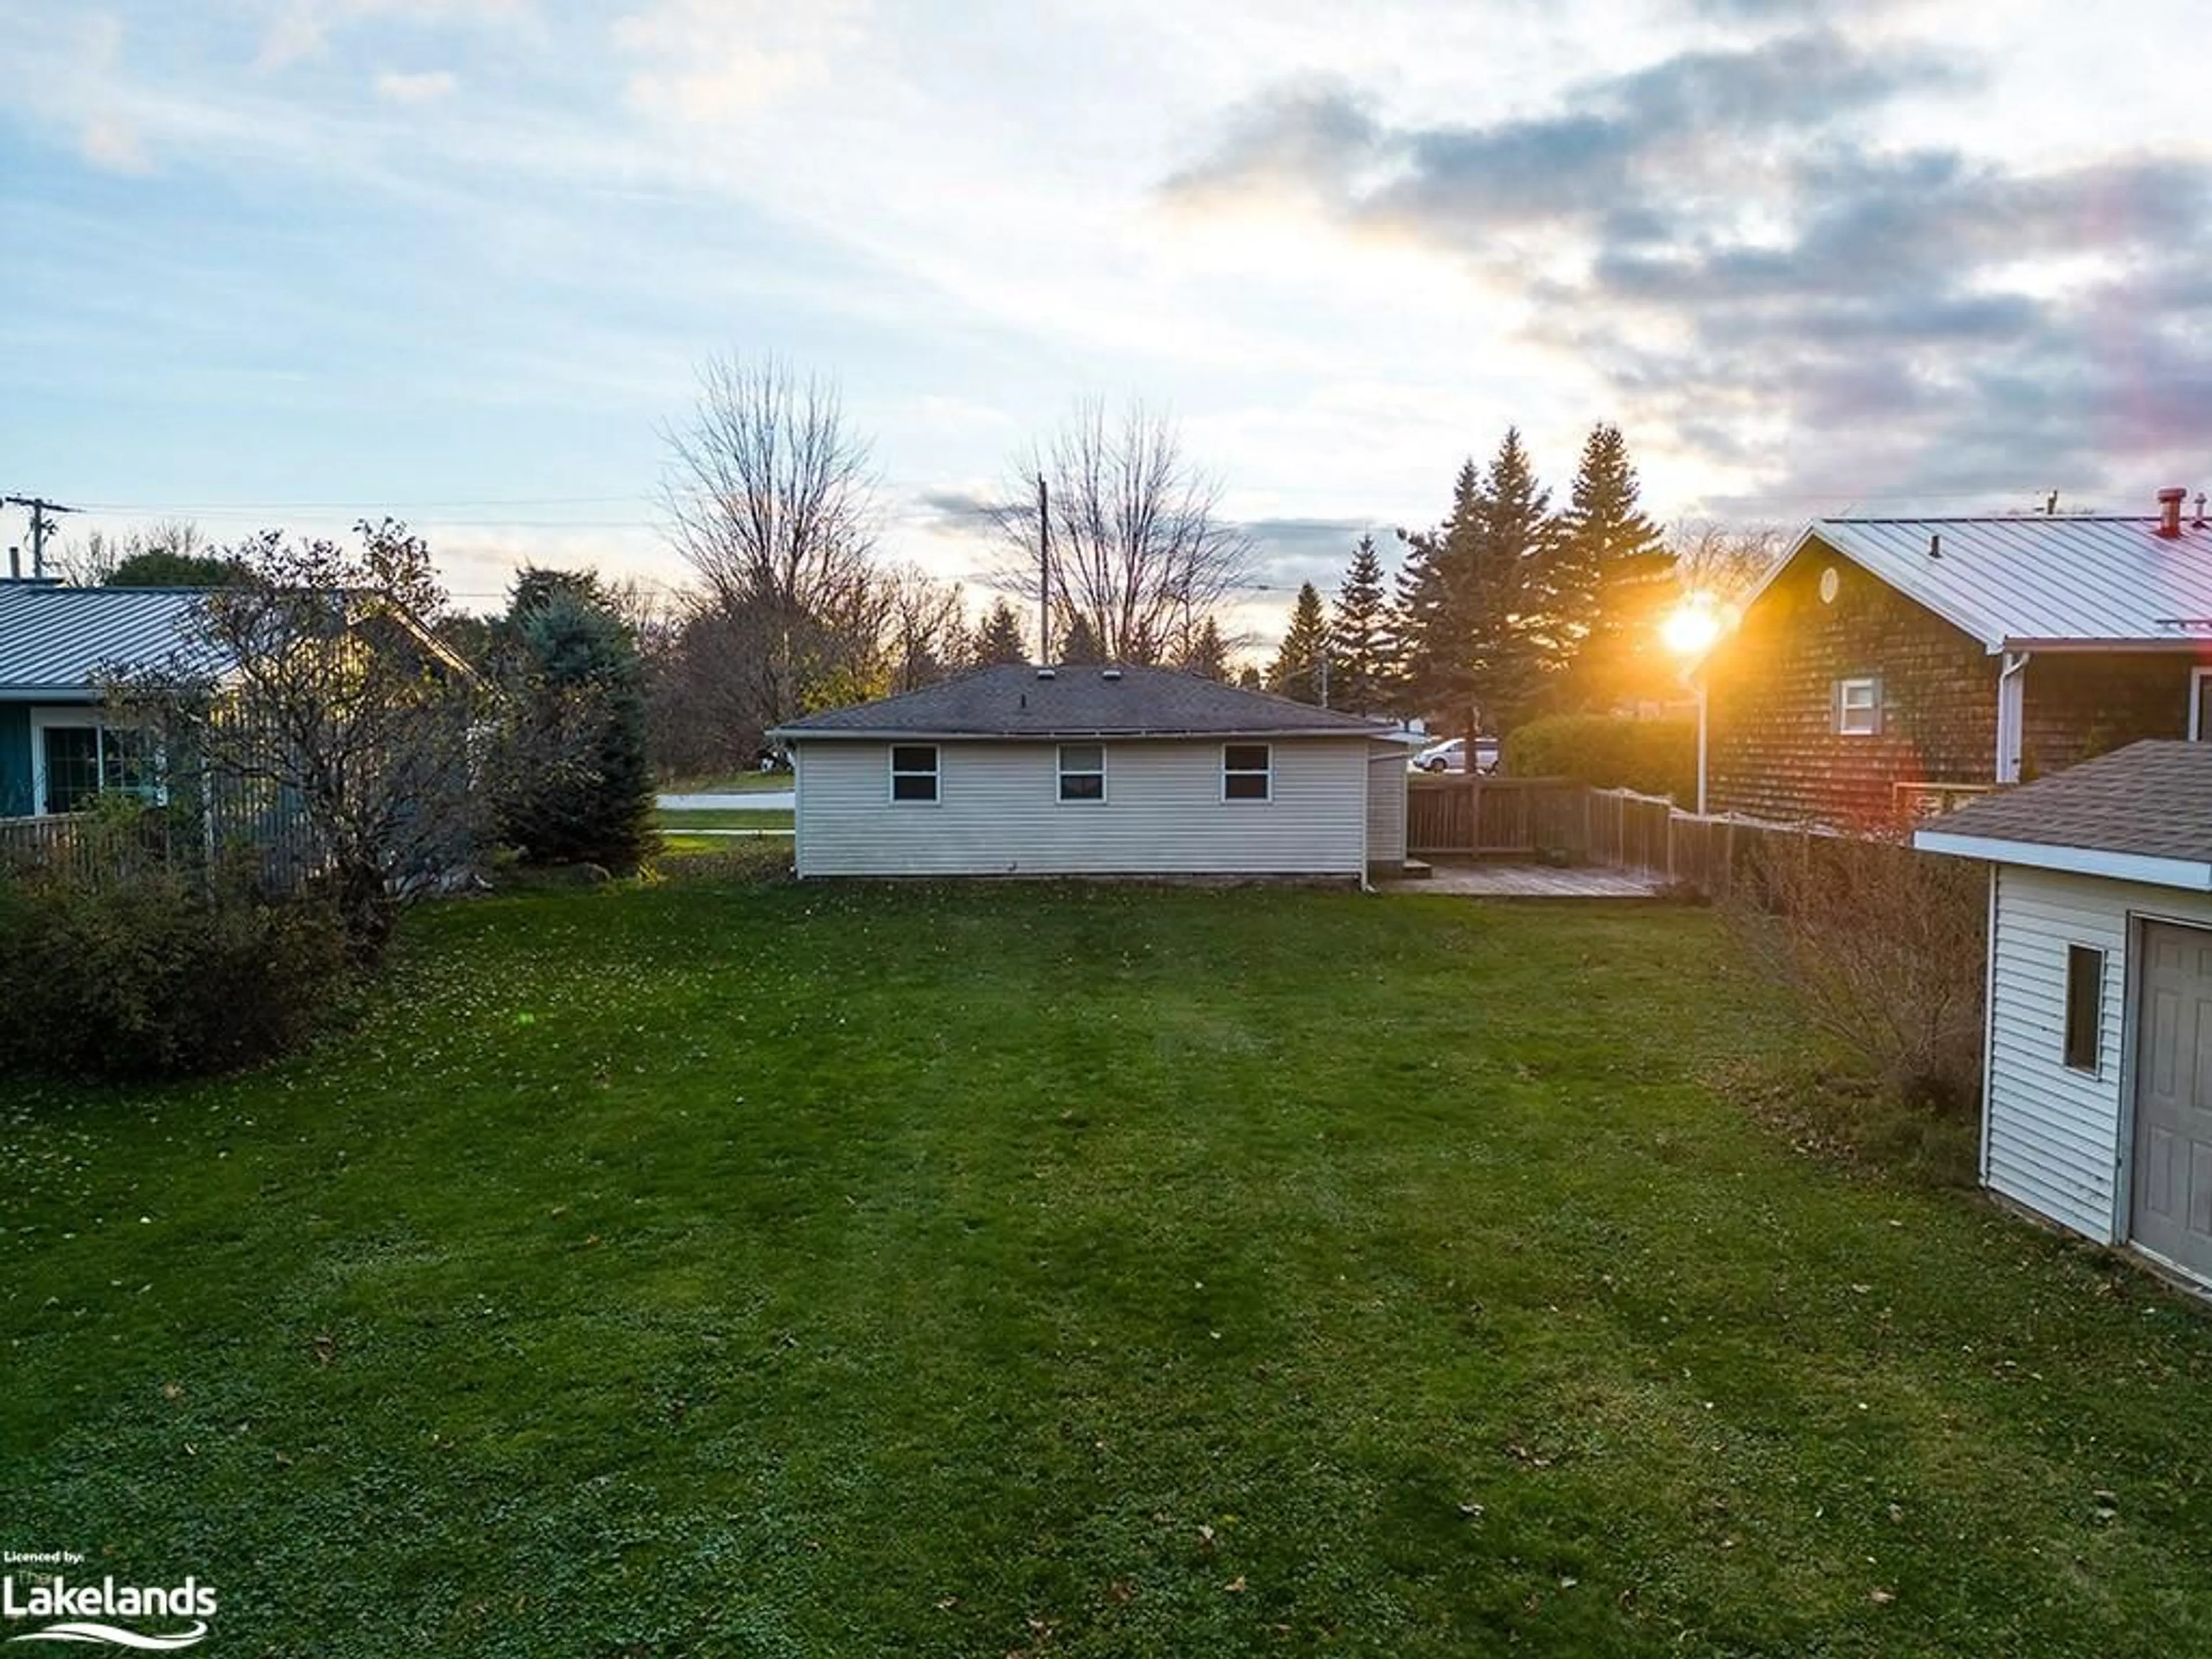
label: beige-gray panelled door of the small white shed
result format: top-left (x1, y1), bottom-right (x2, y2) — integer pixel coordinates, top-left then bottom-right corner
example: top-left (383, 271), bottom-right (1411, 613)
top-left (2133, 922), bottom-right (2212, 1279)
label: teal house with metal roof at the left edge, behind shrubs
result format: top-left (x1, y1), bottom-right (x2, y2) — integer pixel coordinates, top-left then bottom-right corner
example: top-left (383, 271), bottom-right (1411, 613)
top-left (0, 582), bottom-right (203, 819)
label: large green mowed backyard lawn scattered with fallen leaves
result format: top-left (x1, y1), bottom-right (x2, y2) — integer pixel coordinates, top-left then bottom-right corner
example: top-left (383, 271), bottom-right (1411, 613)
top-left (0, 882), bottom-right (2212, 1659)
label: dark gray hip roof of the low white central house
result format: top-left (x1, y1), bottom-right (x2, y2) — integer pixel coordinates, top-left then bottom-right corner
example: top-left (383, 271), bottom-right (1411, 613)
top-left (777, 666), bottom-right (1391, 739)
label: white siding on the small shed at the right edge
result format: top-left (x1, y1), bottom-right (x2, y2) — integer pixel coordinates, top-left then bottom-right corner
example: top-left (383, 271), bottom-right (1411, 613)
top-left (1982, 865), bottom-right (2212, 1243)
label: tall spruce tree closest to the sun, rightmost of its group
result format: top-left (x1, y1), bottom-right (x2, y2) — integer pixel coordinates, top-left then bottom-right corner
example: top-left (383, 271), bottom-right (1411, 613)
top-left (1553, 425), bottom-right (1675, 708)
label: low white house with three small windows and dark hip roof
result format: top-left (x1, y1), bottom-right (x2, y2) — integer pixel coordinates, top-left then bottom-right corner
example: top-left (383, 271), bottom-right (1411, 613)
top-left (772, 666), bottom-right (1407, 880)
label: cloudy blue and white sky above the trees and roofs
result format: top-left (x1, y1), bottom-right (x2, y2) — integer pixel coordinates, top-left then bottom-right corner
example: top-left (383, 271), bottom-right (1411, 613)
top-left (0, 0), bottom-right (2212, 626)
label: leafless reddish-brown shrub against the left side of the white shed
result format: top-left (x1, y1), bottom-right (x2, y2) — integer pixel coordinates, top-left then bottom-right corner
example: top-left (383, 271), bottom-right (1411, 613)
top-left (1721, 834), bottom-right (1988, 1115)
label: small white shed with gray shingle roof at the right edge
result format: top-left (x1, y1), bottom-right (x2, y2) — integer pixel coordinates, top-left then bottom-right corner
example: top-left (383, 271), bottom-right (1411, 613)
top-left (1914, 741), bottom-right (2212, 1285)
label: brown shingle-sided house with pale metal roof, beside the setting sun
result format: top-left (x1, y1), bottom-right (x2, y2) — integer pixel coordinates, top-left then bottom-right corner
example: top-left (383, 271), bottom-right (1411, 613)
top-left (1692, 489), bottom-right (2212, 825)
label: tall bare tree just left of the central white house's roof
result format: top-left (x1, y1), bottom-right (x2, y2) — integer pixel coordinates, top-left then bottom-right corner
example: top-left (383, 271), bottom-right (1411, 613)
top-left (661, 358), bottom-right (885, 726)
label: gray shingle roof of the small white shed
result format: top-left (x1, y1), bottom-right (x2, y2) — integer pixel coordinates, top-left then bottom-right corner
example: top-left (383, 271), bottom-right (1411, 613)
top-left (1920, 739), bottom-right (2212, 865)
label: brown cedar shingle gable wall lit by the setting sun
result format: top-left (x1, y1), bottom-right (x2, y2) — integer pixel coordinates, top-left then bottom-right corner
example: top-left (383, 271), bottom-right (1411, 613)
top-left (1703, 544), bottom-right (1998, 823)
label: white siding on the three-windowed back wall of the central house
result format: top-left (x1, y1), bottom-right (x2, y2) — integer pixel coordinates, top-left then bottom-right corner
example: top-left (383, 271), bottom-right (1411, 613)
top-left (794, 737), bottom-right (1362, 876)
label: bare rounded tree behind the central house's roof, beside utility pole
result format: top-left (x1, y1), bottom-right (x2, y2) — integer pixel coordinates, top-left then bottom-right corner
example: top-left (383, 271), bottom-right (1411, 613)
top-left (991, 400), bottom-right (1252, 664)
